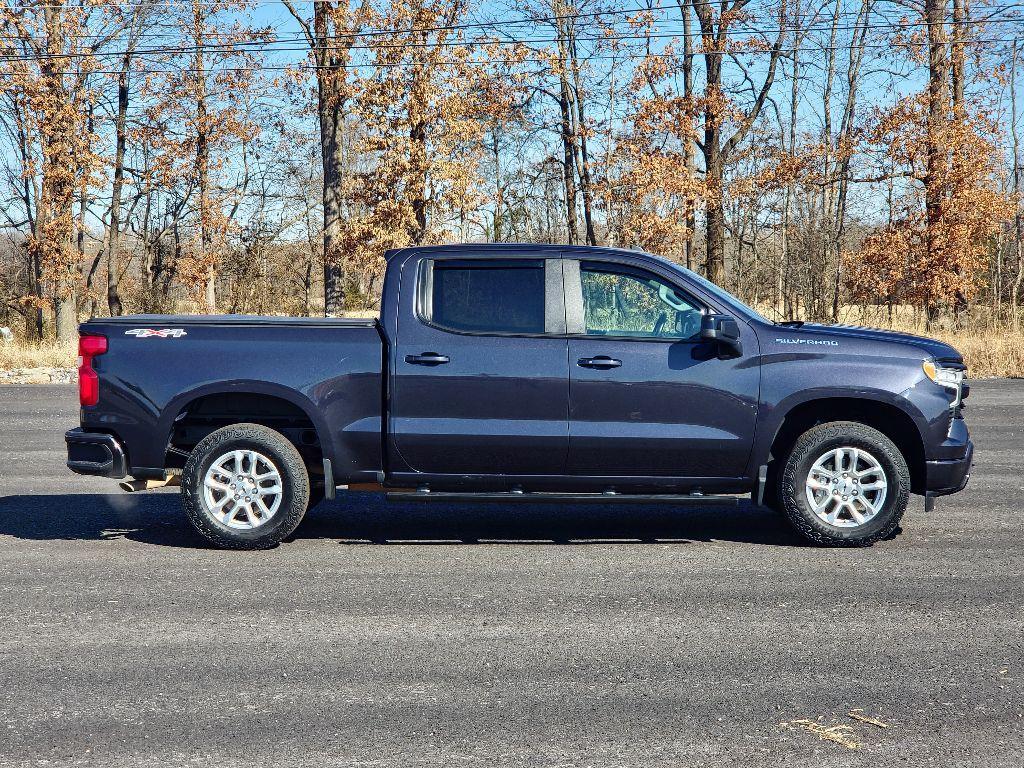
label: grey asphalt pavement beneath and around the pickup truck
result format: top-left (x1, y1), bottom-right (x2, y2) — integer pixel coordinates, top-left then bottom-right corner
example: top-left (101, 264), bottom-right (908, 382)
top-left (0, 381), bottom-right (1024, 768)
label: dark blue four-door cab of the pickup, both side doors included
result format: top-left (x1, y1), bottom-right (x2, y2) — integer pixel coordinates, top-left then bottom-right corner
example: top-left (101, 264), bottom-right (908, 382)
top-left (382, 248), bottom-right (761, 493)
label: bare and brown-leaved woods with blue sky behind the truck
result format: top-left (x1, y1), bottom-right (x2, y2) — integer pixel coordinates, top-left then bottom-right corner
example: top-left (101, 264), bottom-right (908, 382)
top-left (0, 0), bottom-right (1024, 375)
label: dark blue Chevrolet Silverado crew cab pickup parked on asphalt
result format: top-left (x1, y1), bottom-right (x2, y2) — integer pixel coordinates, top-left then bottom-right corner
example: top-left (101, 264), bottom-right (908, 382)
top-left (66, 245), bottom-right (974, 549)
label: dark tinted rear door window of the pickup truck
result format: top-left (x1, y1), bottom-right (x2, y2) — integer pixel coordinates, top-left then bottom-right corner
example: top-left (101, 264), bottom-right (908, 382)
top-left (426, 259), bottom-right (544, 334)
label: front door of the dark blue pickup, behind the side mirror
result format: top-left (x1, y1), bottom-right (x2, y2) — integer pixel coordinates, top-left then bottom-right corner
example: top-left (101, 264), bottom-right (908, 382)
top-left (564, 260), bottom-right (760, 478)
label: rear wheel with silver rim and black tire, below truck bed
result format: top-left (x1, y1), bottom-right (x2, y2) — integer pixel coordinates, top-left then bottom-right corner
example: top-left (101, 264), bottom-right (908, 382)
top-left (181, 424), bottom-right (309, 550)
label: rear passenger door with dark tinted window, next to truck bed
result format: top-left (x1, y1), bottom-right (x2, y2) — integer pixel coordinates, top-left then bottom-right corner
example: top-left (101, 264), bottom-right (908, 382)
top-left (390, 256), bottom-right (568, 475)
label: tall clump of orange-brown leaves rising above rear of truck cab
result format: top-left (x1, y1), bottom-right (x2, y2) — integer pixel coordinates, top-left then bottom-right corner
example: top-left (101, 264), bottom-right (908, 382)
top-left (327, 0), bottom-right (523, 290)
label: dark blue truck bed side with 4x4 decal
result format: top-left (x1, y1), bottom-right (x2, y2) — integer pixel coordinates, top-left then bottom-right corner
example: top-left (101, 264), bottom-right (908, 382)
top-left (81, 314), bottom-right (385, 481)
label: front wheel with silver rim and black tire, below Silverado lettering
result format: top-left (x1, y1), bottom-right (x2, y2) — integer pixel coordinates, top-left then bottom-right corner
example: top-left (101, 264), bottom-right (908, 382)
top-left (777, 421), bottom-right (910, 547)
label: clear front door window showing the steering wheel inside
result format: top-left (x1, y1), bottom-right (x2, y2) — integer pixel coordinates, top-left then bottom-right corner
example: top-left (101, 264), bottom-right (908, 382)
top-left (580, 264), bottom-right (702, 339)
